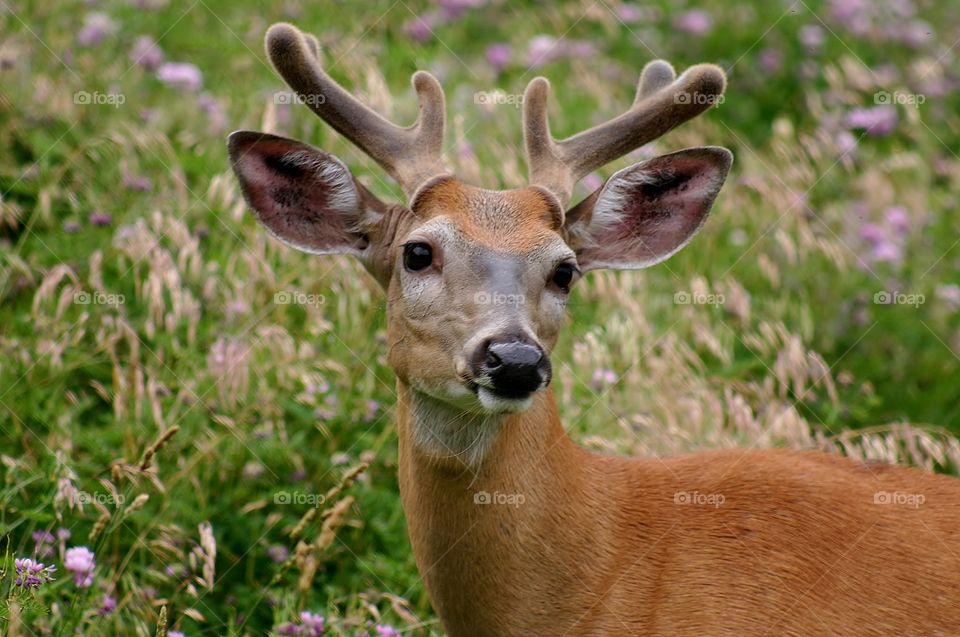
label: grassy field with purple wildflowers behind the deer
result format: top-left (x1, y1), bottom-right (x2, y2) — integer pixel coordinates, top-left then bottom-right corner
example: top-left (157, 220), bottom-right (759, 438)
top-left (0, 0), bottom-right (960, 637)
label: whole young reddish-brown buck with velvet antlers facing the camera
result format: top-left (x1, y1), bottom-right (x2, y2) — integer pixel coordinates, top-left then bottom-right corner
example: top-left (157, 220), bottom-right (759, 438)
top-left (229, 24), bottom-right (960, 637)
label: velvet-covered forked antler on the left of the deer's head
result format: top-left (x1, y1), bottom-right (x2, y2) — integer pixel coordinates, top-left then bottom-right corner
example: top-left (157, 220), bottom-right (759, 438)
top-left (266, 23), bottom-right (446, 198)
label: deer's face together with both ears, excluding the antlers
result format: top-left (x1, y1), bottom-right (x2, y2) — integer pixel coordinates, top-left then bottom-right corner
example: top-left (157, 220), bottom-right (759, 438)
top-left (230, 133), bottom-right (730, 412)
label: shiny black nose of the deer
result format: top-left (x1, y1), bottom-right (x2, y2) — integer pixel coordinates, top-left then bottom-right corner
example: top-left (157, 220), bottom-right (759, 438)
top-left (475, 339), bottom-right (550, 398)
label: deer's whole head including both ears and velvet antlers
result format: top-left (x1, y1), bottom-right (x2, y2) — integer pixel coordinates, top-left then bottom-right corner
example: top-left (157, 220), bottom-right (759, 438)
top-left (229, 24), bottom-right (732, 414)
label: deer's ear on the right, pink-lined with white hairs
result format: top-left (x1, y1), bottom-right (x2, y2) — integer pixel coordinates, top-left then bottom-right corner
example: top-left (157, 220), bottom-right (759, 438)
top-left (565, 146), bottom-right (733, 271)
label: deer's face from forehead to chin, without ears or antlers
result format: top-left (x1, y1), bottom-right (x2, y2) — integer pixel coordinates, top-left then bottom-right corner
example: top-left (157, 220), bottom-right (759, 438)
top-left (388, 178), bottom-right (579, 412)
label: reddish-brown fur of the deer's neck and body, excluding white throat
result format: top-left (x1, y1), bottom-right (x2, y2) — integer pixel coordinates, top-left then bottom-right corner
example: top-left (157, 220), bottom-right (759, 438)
top-left (398, 384), bottom-right (960, 637)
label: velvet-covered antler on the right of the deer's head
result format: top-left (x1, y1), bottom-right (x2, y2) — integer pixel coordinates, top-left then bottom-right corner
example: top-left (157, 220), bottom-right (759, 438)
top-left (523, 60), bottom-right (726, 206)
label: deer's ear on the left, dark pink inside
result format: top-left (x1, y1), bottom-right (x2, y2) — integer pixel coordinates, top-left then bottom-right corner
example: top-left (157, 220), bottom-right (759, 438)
top-left (228, 131), bottom-right (386, 256)
